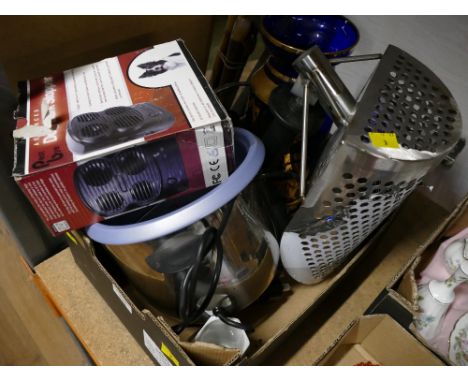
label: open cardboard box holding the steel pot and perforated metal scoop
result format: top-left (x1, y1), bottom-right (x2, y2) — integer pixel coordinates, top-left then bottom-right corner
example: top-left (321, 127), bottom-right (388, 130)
top-left (63, 213), bottom-right (392, 365)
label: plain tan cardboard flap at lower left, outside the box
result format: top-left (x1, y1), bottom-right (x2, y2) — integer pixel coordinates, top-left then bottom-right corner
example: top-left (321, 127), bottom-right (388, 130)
top-left (35, 249), bottom-right (154, 365)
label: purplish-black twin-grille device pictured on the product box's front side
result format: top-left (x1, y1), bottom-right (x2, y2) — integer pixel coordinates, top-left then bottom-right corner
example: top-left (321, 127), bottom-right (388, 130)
top-left (74, 137), bottom-right (188, 217)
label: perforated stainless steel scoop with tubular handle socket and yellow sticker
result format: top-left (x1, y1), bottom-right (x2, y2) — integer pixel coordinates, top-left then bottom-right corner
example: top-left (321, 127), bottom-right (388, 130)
top-left (281, 45), bottom-right (461, 284)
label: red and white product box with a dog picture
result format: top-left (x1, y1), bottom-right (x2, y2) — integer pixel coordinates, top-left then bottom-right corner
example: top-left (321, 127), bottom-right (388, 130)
top-left (13, 40), bottom-right (234, 235)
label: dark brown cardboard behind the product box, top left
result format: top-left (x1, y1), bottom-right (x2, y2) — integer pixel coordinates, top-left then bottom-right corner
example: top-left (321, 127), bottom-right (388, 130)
top-left (0, 15), bottom-right (213, 87)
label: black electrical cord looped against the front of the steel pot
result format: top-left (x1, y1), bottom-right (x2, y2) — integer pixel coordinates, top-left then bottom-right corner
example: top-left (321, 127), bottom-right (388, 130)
top-left (173, 201), bottom-right (251, 334)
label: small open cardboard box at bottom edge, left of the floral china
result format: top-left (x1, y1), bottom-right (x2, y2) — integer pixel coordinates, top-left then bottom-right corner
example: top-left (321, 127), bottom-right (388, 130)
top-left (317, 315), bottom-right (444, 366)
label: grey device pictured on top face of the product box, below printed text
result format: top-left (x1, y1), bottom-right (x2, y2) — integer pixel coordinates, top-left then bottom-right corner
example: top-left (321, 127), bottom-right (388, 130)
top-left (66, 102), bottom-right (175, 154)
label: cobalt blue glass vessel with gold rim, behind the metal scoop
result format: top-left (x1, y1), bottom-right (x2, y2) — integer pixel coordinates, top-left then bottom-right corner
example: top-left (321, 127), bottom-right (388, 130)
top-left (260, 16), bottom-right (359, 78)
